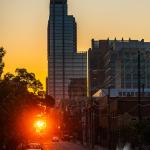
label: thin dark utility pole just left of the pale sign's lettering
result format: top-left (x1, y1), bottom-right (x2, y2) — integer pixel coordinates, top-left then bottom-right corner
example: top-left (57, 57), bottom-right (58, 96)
top-left (107, 87), bottom-right (111, 150)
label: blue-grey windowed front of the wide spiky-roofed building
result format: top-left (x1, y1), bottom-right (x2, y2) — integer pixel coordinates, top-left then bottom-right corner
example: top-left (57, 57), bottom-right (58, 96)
top-left (104, 39), bottom-right (150, 89)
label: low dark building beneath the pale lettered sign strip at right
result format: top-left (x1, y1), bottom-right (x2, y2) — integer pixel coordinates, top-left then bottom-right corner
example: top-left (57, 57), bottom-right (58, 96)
top-left (82, 96), bottom-right (150, 149)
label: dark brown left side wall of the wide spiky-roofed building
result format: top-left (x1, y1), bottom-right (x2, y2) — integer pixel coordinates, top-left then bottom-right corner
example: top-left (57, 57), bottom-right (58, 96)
top-left (88, 40), bottom-right (109, 94)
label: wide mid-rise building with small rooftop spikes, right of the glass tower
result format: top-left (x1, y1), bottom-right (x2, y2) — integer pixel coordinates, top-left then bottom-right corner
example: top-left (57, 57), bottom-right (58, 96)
top-left (89, 39), bottom-right (150, 89)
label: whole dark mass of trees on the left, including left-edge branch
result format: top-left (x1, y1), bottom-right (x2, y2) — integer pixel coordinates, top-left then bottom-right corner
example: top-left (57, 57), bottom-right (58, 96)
top-left (0, 47), bottom-right (55, 150)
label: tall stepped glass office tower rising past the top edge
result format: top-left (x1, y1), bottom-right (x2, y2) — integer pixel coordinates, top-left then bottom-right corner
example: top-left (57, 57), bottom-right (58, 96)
top-left (47, 0), bottom-right (87, 100)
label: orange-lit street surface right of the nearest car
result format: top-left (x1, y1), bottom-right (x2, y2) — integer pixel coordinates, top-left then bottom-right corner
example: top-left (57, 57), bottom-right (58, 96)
top-left (44, 142), bottom-right (87, 150)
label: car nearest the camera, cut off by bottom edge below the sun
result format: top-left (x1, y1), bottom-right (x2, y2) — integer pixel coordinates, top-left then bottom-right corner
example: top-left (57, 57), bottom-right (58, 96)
top-left (23, 143), bottom-right (43, 150)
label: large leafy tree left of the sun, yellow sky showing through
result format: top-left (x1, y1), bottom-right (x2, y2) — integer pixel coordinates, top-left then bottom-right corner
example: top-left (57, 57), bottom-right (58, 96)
top-left (0, 69), bottom-right (44, 149)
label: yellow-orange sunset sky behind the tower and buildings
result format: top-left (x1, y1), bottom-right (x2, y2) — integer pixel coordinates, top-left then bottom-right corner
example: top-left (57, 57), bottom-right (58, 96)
top-left (0, 0), bottom-right (150, 89)
